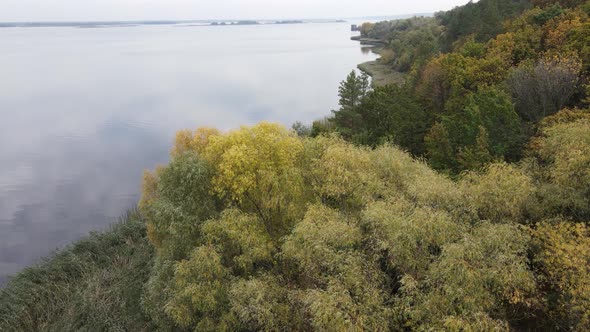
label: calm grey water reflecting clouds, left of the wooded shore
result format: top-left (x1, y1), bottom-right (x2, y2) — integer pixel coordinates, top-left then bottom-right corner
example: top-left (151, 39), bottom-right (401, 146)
top-left (0, 23), bottom-right (374, 282)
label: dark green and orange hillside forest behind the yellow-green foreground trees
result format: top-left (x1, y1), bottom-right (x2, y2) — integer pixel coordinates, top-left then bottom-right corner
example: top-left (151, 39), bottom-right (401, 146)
top-left (338, 0), bottom-right (590, 176)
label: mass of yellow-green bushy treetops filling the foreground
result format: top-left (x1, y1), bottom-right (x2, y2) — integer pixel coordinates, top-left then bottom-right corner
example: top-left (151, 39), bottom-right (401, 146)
top-left (135, 115), bottom-right (590, 331)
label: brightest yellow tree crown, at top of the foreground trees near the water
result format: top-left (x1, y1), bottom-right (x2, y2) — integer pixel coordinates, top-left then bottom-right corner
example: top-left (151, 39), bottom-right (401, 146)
top-left (203, 122), bottom-right (306, 238)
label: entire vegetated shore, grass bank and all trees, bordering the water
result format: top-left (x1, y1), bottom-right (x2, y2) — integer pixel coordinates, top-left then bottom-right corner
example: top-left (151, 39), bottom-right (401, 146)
top-left (0, 0), bottom-right (590, 331)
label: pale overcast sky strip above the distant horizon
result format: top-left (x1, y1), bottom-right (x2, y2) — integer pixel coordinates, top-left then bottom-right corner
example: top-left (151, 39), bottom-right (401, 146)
top-left (0, 0), bottom-right (468, 22)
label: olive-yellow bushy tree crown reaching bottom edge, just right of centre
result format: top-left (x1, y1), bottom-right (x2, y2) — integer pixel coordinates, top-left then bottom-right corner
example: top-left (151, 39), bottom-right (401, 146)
top-left (282, 206), bottom-right (388, 331)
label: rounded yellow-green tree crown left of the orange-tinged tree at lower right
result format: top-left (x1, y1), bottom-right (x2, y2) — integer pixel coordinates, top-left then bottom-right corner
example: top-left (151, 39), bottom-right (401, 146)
top-left (413, 222), bottom-right (536, 330)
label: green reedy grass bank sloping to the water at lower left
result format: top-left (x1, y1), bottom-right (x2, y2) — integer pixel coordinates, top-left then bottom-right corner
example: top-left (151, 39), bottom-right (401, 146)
top-left (0, 212), bottom-right (153, 331)
